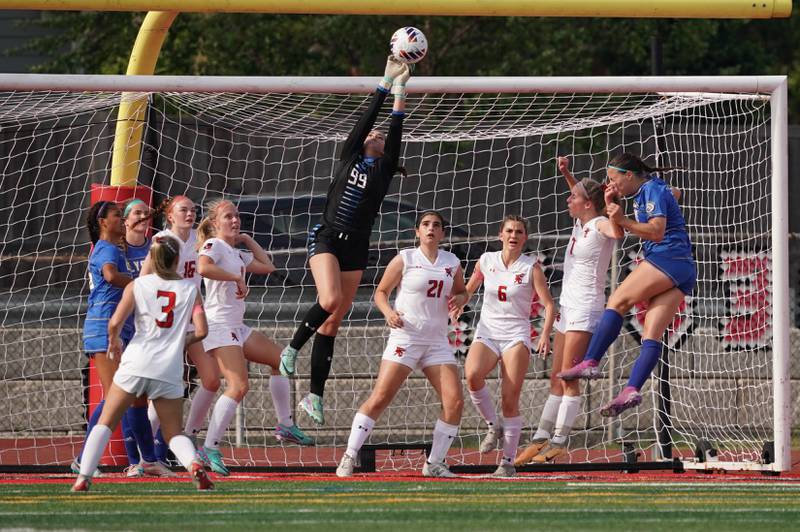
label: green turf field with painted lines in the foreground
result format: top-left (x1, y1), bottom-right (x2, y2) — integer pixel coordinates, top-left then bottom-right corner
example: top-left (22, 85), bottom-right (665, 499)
top-left (0, 480), bottom-right (800, 532)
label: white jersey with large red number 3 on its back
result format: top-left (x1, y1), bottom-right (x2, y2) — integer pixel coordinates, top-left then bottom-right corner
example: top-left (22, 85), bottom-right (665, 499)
top-left (117, 274), bottom-right (197, 384)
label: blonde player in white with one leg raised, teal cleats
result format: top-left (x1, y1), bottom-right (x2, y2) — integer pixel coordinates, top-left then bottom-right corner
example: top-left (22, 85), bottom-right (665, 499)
top-left (197, 200), bottom-right (314, 475)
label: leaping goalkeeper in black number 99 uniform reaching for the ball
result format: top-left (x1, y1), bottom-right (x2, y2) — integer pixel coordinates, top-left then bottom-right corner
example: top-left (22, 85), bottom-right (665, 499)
top-left (280, 56), bottom-right (410, 425)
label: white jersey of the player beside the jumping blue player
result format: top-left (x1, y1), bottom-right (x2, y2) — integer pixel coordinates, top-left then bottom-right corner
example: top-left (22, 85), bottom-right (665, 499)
top-left (559, 216), bottom-right (614, 312)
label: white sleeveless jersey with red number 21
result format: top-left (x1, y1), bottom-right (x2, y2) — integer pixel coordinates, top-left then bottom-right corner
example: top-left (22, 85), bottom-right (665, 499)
top-left (389, 248), bottom-right (461, 345)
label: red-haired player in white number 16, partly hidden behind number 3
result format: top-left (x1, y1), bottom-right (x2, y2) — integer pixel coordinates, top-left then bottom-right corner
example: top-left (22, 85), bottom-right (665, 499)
top-left (142, 195), bottom-right (220, 458)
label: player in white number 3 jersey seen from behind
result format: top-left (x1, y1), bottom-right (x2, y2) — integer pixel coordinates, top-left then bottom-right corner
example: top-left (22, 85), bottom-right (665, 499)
top-left (72, 238), bottom-right (214, 491)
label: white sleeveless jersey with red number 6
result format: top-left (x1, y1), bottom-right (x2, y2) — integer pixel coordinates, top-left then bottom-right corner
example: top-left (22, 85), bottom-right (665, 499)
top-left (476, 251), bottom-right (537, 339)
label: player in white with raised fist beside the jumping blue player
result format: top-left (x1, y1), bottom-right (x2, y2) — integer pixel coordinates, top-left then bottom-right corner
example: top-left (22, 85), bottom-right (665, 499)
top-left (514, 157), bottom-right (624, 465)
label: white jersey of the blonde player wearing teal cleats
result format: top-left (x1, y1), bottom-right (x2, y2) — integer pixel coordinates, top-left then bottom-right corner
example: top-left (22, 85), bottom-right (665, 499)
top-left (200, 238), bottom-right (253, 327)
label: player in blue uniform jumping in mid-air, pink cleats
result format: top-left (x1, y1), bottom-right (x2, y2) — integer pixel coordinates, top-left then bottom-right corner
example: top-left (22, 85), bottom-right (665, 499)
top-left (559, 153), bottom-right (697, 416)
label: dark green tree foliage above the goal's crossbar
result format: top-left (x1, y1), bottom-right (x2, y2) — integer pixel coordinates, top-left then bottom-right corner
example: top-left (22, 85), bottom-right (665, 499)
top-left (10, 10), bottom-right (800, 117)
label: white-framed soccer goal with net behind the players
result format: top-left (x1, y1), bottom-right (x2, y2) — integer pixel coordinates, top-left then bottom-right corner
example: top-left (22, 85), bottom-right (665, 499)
top-left (0, 75), bottom-right (792, 472)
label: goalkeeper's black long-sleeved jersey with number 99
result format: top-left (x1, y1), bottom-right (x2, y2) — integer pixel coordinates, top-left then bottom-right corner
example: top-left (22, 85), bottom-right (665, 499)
top-left (323, 89), bottom-right (404, 238)
